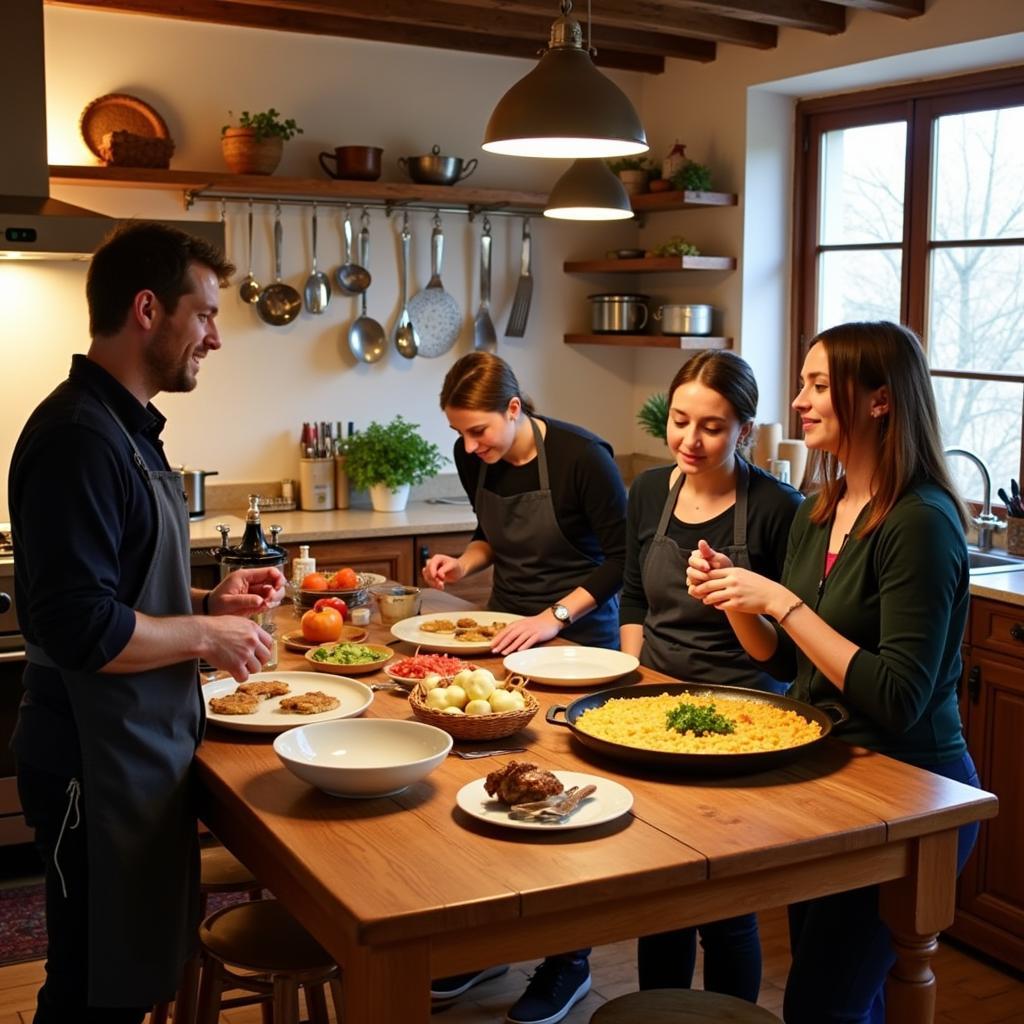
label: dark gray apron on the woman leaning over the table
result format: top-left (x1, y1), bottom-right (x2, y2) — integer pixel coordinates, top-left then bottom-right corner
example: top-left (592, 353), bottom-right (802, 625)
top-left (473, 419), bottom-right (618, 648)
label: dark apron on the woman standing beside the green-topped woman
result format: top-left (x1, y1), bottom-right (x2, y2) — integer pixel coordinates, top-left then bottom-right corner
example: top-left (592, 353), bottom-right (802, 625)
top-left (640, 458), bottom-right (785, 693)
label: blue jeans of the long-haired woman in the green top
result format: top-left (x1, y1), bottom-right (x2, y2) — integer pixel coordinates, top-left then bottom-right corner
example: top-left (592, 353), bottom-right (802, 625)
top-left (782, 754), bottom-right (979, 1024)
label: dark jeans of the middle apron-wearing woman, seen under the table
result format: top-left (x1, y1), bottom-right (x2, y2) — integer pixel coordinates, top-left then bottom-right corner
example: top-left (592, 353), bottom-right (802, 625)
top-left (637, 913), bottom-right (761, 1002)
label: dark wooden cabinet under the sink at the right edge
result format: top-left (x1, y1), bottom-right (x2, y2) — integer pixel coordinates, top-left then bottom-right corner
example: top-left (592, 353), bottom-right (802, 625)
top-left (950, 598), bottom-right (1024, 971)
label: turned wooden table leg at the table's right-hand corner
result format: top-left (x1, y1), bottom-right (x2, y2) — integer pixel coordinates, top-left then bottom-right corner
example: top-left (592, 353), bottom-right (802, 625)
top-left (880, 829), bottom-right (956, 1024)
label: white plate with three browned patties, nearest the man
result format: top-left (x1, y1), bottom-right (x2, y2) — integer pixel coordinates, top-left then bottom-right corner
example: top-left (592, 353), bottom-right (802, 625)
top-left (203, 672), bottom-right (374, 732)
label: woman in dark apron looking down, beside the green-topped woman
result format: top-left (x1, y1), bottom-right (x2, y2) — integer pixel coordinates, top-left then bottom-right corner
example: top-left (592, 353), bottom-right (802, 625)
top-left (620, 351), bottom-right (801, 1002)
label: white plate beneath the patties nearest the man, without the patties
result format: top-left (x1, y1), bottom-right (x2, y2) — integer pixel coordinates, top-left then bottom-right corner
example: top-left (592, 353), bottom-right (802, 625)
top-left (203, 672), bottom-right (374, 732)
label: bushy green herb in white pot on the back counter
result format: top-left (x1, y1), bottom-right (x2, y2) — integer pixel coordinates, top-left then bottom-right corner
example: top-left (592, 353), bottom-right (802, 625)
top-left (345, 416), bottom-right (447, 512)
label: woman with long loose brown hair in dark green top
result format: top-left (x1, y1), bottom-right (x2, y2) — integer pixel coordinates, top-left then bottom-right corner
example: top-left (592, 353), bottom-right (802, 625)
top-left (687, 323), bottom-right (978, 1024)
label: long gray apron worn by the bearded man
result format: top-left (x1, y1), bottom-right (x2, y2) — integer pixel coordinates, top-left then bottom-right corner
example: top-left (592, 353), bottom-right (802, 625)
top-left (28, 402), bottom-right (205, 1007)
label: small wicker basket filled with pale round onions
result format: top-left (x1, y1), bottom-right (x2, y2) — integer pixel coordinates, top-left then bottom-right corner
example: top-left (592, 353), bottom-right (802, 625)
top-left (409, 669), bottom-right (541, 739)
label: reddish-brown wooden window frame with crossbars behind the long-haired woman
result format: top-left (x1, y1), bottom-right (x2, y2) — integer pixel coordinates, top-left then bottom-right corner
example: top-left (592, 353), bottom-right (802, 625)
top-left (790, 65), bottom-right (1024, 478)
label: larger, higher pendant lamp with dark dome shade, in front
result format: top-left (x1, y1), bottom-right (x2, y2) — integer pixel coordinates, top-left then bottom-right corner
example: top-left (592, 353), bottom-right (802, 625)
top-left (483, 0), bottom-right (650, 159)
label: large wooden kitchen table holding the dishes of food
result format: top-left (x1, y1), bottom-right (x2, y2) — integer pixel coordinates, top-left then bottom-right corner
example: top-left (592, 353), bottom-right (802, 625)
top-left (199, 593), bottom-right (996, 1024)
